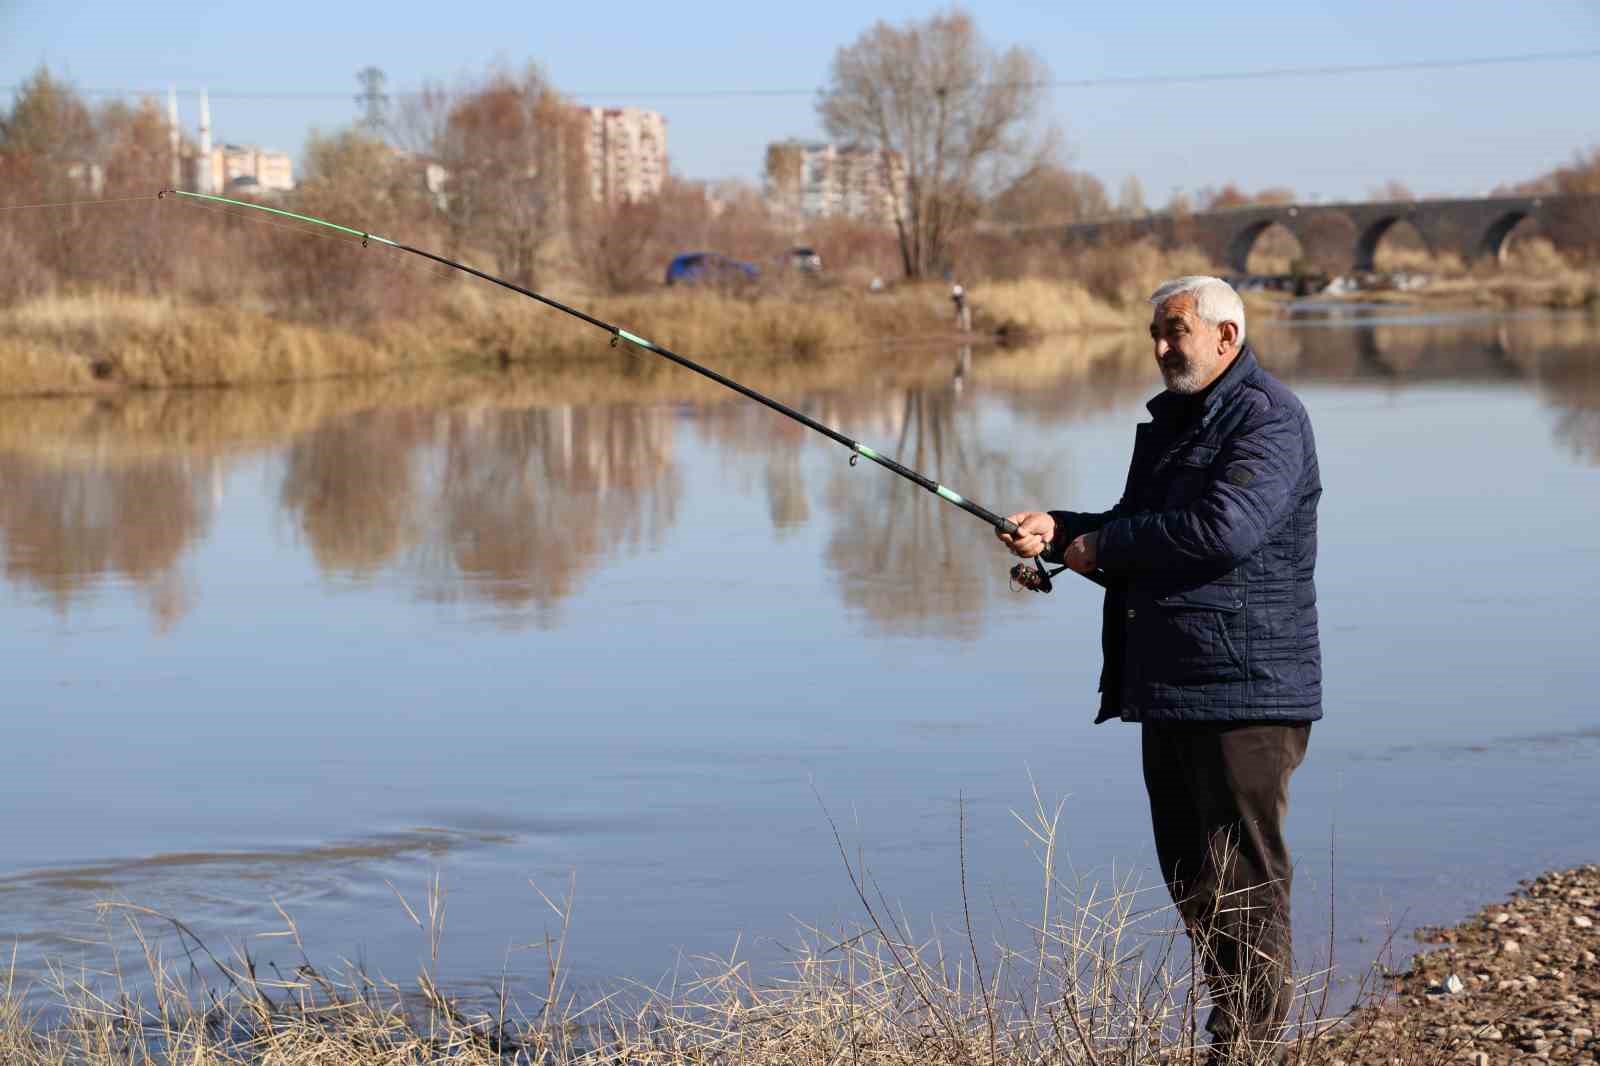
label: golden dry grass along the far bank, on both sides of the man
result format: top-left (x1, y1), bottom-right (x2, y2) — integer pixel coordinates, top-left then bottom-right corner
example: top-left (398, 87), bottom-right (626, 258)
top-left (9, 240), bottom-right (1600, 395)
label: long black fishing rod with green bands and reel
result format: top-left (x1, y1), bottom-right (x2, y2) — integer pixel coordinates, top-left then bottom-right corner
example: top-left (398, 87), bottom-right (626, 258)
top-left (155, 189), bottom-right (1104, 592)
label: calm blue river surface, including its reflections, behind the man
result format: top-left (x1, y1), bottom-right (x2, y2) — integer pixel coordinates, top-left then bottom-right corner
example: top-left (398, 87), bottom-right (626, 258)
top-left (0, 305), bottom-right (1600, 996)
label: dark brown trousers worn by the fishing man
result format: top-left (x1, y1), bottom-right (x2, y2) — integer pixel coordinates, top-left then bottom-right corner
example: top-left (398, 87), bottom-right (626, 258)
top-left (1142, 722), bottom-right (1310, 1050)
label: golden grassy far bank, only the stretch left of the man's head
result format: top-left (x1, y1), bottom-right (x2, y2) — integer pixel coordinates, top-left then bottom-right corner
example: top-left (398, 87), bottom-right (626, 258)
top-left (0, 280), bottom-right (1130, 395)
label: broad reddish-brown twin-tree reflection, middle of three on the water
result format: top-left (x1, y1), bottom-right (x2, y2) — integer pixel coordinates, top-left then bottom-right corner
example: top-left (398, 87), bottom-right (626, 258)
top-left (282, 407), bottom-right (677, 624)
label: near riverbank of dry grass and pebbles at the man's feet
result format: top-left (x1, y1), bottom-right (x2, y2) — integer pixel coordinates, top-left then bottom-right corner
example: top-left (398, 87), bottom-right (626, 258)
top-left (0, 866), bottom-right (1600, 1066)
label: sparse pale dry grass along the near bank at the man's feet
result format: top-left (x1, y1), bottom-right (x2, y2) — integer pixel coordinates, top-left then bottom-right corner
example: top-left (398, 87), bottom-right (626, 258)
top-left (0, 795), bottom-right (1448, 1066)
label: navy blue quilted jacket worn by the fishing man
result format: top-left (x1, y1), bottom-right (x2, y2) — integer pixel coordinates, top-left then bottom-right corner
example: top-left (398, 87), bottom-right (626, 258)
top-left (1051, 344), bottom-right (1322, 722)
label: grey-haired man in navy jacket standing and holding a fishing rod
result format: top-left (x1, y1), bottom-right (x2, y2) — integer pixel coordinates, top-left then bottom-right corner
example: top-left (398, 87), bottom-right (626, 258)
top-left (997, 277), bottom-right (1322, 1063)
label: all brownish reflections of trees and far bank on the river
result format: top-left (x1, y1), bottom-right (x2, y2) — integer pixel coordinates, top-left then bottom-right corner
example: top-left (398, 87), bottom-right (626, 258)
top-left (0, 314), bottom-right (1600, 634)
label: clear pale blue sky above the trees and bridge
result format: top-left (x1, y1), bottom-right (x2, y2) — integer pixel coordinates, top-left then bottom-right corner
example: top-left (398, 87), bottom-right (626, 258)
top-left (9, 0), bottom-right (1600, 203)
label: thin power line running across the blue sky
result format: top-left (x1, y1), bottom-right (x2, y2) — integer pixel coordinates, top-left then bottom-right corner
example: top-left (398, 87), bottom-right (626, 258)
top-left (5, 48), bottom-right (1600, 101)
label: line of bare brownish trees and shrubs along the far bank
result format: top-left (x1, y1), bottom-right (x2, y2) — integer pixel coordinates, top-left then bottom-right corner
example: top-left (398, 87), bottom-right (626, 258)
top-left (0, 10), bottom-right (1600, 312)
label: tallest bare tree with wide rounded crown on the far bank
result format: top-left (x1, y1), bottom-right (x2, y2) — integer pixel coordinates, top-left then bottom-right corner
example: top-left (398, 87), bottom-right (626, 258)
top-left (818, 11), bottom-right (1050, 277)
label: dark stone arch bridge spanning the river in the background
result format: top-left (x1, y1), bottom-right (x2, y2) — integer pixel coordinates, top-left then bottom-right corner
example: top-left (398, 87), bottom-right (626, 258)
top-left (1066, 195), bottom-right (1600, 274)
